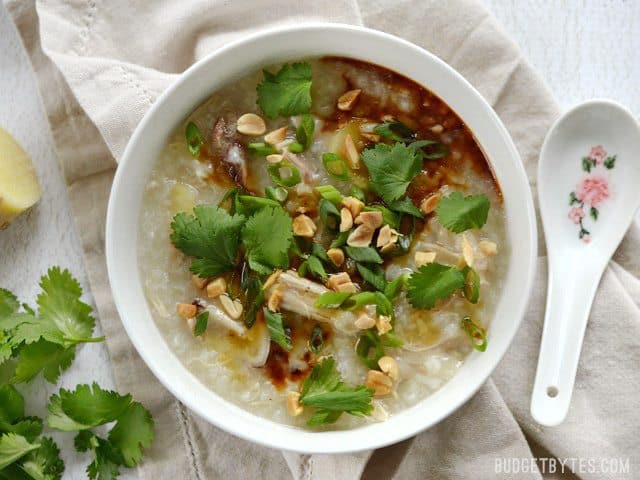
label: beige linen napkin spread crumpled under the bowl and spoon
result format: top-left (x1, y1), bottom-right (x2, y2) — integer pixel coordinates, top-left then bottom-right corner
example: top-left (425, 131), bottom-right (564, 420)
top-left (5, 0), bottom-right (640, 480)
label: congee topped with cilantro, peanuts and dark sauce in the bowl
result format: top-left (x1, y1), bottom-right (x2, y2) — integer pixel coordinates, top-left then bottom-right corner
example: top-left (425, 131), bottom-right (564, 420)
top-left (138, 57), bottom-right (508, 430)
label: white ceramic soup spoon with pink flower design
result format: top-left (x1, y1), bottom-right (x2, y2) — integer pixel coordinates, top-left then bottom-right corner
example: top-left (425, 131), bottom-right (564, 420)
top-left (531, 100), bottom-right (640, 426)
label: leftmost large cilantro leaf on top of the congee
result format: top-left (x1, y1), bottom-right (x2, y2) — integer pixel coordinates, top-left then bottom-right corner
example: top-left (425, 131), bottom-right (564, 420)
top-left (171, 205), bottom-right (245, 278)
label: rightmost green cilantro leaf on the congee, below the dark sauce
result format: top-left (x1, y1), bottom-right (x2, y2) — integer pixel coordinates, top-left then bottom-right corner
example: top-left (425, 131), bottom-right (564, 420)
top-left (436, 192), bottom-right (490, 233)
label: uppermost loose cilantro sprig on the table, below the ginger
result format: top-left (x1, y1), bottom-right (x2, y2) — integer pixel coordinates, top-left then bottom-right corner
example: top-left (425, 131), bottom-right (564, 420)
top-left (0, 267), bottom-right (104, 383)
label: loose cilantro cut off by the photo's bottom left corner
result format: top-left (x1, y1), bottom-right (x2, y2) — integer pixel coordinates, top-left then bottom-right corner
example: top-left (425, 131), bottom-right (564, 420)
top-left (0, 385), bottom-right (64, 480)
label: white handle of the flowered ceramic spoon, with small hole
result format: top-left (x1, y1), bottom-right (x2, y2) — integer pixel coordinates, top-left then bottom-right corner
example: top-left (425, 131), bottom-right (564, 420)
top-left (531, 257), bottom-right (606, 427)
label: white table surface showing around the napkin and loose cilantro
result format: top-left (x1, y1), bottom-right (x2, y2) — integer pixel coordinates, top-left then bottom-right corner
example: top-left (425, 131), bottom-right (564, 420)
top-left (0, 0), bottom-right (640, 480)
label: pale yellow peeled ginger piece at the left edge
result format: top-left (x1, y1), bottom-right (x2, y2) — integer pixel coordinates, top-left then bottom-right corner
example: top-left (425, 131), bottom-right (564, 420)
top-left (0, 128), bottom-right (40, 229)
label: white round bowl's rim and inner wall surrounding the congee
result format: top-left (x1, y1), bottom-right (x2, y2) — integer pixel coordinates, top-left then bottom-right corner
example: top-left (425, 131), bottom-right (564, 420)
top-left (106, 24), bottom-right (537, 453)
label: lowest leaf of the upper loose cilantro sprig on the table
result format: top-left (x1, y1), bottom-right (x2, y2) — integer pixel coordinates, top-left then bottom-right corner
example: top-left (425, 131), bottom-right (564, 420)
top-left (12, 339), bottom-right (76, 383)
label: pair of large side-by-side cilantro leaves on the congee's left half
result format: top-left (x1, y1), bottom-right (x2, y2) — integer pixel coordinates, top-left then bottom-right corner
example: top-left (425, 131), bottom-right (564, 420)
top-left (171, 202), bottom-right (293, 278)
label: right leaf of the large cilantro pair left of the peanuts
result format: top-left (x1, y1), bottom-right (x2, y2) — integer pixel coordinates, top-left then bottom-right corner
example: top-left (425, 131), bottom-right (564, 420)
top-left (242, 207), bottom-right (293, 275)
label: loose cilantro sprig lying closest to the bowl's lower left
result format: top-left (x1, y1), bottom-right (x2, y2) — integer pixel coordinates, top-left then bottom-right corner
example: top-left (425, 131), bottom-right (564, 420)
top-left (47, 383), bottom-right (154, 480)
